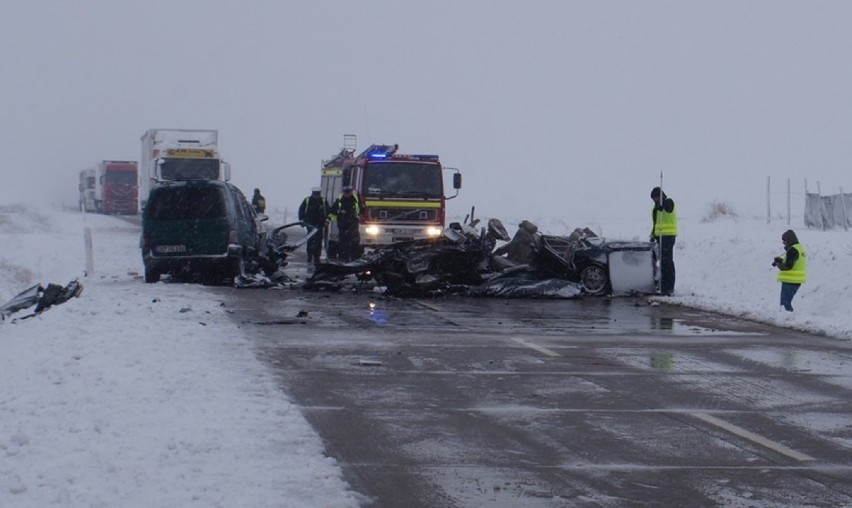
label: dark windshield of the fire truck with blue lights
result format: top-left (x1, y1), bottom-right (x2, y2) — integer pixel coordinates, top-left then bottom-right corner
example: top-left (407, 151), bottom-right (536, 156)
top-left (364, 161), bottom-right (444, 199)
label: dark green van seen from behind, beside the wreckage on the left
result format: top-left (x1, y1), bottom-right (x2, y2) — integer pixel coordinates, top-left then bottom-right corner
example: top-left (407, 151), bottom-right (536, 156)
top-left (142, 180), bottom-right (260, 282)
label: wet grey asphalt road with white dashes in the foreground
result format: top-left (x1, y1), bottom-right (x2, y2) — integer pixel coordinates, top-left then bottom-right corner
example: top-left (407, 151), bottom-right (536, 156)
top-left (210, 262), bottom-right (852, 507)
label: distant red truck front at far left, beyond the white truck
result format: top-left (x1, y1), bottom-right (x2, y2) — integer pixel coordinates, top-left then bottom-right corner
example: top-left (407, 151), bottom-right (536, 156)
top-left (95, 161), bottom-right (139, 215)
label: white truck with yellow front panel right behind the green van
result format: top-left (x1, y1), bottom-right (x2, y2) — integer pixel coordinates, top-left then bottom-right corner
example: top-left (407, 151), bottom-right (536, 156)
top-left (139, 129), bottom-right (231, 212)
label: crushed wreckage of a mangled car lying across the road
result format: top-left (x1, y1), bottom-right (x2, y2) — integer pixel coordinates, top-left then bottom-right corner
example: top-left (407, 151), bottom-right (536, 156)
top-left (305, 219), bottom-right (654, 298)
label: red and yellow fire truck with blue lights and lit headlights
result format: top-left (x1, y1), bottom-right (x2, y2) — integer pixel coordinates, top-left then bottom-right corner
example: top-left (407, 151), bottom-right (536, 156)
top-left (320, 135), bottom-right (462, 258)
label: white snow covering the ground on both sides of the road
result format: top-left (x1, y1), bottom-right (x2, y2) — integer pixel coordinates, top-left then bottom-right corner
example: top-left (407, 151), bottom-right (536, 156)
top-left (0, 205), bottom-right (852, 508)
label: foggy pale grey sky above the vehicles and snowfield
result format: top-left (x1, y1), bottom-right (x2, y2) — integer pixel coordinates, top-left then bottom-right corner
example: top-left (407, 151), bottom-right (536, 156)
top-left (0, 0), bottom-right (852, 225)
